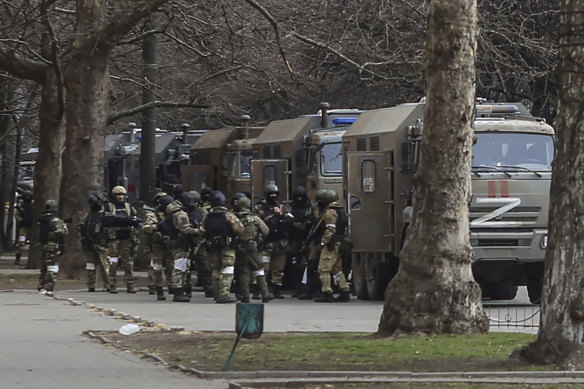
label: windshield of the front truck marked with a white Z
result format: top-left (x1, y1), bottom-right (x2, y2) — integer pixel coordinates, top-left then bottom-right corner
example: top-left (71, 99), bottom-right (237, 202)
top-left (472, 132), bottom-right (554, 171)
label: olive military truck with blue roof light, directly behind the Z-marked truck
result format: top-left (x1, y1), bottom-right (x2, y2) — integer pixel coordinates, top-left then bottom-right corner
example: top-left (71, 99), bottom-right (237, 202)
top-left (251, 103), bottom-right (361, 202)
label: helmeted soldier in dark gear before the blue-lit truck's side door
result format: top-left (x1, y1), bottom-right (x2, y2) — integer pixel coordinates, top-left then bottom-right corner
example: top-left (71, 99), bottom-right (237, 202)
top-left (253, 184), bottom-right (293, 299)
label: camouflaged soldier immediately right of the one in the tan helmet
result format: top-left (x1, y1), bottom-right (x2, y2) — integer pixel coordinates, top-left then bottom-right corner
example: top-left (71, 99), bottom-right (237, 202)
top-left (142, 192), bottom-right (173, 301)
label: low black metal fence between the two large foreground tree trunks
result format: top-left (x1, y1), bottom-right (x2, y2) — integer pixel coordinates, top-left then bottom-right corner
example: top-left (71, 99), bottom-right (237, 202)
top-left (483, 303), bottom-right (540, 328)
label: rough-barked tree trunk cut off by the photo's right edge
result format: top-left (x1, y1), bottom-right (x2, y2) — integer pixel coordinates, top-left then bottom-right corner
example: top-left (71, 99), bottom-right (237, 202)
top-left (520, 0), bottom-right (584, 370)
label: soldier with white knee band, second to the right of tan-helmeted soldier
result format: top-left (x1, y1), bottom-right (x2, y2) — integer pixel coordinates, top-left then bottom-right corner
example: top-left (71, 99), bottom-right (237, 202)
top-left (159, 192), bottom-right (201, 303)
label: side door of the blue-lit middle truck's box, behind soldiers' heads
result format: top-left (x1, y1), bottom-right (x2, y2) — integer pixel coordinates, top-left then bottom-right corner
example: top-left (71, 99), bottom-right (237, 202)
top-left (251, 159), bottom-right (291, 204)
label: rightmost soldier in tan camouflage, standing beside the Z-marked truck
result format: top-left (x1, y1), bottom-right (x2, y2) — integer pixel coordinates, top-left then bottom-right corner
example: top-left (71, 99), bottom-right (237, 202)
top-left (314, 189), bottom-right (351, 303)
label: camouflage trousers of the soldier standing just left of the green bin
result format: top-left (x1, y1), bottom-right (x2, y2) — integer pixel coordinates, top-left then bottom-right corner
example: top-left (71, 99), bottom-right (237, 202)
top-left (207, 246), bottom-right (235, 300)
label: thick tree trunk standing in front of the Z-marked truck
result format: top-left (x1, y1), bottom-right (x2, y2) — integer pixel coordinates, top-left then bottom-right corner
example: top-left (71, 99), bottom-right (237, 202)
top-left (378, 0), bottom-right (489, 335)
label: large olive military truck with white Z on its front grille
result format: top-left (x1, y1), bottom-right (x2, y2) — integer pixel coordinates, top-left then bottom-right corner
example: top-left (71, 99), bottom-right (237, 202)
top-left (343, 103), bottom-right (554, 302)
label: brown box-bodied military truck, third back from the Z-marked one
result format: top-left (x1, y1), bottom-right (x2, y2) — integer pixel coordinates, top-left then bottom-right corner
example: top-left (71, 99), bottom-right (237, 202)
top-left (182, 118), bottom-right (264, 198)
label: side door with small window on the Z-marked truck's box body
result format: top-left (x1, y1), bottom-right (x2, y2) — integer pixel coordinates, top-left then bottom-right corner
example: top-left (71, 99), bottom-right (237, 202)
top-left (346, 151), bottom-right (394, 253)
